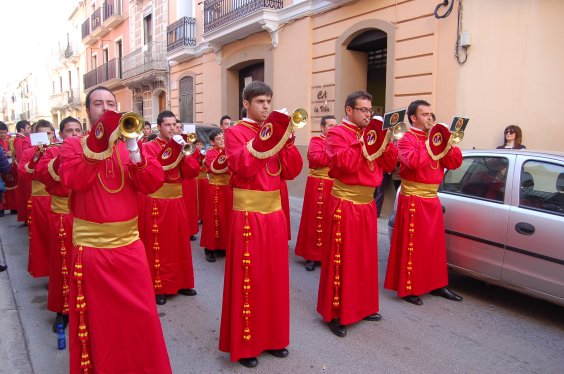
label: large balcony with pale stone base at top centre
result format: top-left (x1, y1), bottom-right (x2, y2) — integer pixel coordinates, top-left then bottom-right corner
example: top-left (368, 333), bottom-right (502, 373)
top-left (204, 0), bottom-right (284, 45)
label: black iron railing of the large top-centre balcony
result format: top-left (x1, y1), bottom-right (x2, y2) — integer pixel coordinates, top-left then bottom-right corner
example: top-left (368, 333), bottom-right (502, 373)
top-left (204, 0), bottom-right (284, 33)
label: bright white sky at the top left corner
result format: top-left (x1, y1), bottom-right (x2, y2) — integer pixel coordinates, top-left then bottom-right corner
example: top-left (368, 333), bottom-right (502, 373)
top-left (0, 0), bottom-right (74, 91)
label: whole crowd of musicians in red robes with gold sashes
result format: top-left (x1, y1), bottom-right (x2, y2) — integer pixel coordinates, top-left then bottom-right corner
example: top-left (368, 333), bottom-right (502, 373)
top-left (0, 81), bottom-right (462, 373)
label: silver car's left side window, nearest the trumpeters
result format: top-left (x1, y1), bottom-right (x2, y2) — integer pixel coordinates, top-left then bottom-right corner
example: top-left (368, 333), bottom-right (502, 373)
top-left (439, 156), bottom-right (509, 203)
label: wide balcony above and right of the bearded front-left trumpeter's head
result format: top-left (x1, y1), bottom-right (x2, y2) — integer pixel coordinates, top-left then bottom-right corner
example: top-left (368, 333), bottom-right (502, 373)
top-left (123, 42), bottom-right (167, 81)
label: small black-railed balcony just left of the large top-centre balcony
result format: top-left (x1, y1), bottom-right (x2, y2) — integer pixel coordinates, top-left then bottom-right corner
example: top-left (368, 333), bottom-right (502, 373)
top-left (166, 17), bottom-right (196, 62)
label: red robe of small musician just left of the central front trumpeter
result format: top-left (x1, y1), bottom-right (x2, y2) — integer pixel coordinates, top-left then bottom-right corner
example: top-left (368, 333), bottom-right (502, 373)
top-left (200, 147), bottom-right (233, 250)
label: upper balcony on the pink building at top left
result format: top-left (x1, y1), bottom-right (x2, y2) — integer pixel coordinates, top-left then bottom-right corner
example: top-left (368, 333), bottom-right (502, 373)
top-left (82, 0), bottom-right (125, 45)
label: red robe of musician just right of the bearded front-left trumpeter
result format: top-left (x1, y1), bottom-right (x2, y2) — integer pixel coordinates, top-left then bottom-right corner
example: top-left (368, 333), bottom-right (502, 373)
top-left (139, 138), bottom-right (200, 295)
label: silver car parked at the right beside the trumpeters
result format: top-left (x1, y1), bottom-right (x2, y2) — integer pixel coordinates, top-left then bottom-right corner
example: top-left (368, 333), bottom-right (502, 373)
top-left (388, 149), bottom-right (564, 306)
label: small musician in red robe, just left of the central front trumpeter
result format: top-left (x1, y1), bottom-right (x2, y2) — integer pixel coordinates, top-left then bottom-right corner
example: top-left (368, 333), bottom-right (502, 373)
top-left (200, 129), bottom-right (233, 262)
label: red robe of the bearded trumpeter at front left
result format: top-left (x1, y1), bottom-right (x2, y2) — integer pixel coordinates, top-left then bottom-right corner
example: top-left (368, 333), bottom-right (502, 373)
top-left (59, 138), bottom-right (171, 374)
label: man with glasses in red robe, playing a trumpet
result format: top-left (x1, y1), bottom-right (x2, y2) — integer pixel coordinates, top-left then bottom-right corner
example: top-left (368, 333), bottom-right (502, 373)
top-left (317, 91), bottom-right (397, 337)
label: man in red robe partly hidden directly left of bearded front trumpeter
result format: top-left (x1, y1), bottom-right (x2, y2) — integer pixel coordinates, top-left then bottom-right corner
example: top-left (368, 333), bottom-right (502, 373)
top-left (35, 117), bottom-right (82, 332)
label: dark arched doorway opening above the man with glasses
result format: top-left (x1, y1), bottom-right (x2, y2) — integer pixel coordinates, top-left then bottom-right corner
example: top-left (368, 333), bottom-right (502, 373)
top-left (347, 29), bottom-right (388, 116)
